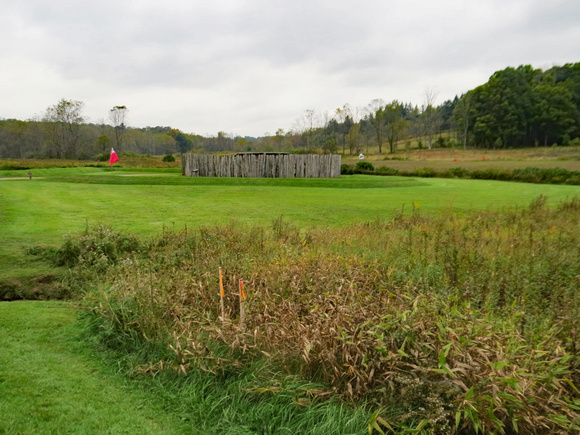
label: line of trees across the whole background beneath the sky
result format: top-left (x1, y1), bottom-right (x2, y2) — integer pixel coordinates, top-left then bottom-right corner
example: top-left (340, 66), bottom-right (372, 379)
top-left (0, 63), bottom-right (580, 160)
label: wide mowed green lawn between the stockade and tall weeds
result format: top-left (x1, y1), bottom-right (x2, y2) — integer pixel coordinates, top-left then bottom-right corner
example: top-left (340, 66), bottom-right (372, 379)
top-left (0, 168), bottom-right (580, 278)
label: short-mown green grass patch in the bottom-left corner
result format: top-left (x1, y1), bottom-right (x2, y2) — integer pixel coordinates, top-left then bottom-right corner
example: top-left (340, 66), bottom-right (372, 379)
top-left (0, 302), bottom-right (194, 434)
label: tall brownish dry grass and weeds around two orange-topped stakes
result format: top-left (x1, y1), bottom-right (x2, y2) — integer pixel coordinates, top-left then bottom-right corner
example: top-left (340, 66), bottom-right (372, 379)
top-left (67, 197), bottom-right (580, 433)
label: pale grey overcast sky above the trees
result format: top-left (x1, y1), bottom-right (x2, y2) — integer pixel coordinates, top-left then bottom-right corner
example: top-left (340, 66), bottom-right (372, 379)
top-left (0, 0), bottom-right (580, 136)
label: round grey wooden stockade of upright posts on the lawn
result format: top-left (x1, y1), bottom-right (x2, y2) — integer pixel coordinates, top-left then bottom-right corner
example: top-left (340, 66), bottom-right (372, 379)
top-left (181, 153), bottom-right (341, 178)
